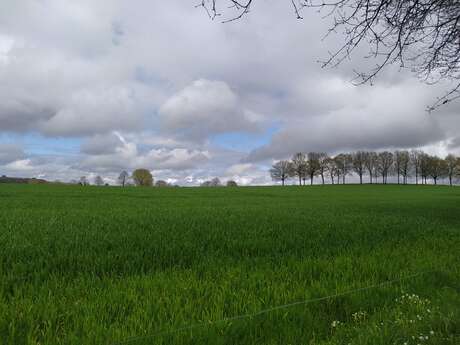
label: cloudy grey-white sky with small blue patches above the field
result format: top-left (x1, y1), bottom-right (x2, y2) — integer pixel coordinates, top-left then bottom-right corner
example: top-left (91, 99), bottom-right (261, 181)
top-left (0, 0), bottom-right (460, 185)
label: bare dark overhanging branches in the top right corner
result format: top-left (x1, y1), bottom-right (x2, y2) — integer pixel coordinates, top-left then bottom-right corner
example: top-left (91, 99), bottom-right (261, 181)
top-left (203, 0), bottom-right (460, 110)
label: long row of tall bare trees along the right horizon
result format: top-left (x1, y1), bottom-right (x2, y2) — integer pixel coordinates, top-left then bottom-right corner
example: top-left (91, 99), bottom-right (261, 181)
top-left (270, 150), bottom-right (460, 186)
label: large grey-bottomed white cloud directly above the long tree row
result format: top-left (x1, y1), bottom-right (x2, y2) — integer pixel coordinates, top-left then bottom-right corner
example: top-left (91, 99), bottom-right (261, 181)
top-left (247, 83), bottom-right (444, 161)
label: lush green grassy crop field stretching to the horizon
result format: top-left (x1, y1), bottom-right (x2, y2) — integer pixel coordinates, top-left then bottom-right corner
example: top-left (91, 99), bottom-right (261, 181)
top-left (0, 185), bottom-right (460, 345)
